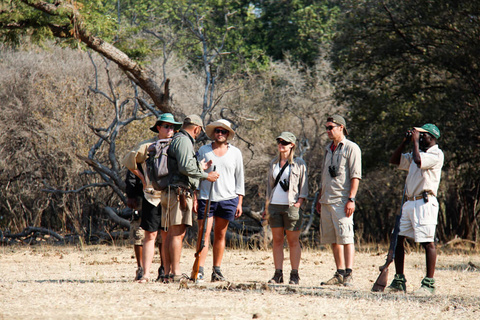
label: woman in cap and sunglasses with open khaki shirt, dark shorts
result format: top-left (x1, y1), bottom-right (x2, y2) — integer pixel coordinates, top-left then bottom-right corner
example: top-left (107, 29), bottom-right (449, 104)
top-left (263, 132), bottom-right (308, 284)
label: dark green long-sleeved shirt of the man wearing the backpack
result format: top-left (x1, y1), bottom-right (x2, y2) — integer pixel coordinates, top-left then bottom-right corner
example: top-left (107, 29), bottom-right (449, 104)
top-left (168, 130), bottom-right (208, 190)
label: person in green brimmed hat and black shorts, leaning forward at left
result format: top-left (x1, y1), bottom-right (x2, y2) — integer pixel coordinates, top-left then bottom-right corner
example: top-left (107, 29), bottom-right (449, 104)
top-left (123, 113), bottom-right (181, 283)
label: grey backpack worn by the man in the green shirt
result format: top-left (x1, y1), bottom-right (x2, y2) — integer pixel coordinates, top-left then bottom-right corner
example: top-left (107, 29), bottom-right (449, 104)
top-left (145, 139), bottom-right (172, 190)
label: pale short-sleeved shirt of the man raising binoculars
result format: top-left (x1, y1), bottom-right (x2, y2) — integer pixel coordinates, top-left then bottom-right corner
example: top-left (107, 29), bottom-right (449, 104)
top-left (398, 145), bottom-right (444, 197)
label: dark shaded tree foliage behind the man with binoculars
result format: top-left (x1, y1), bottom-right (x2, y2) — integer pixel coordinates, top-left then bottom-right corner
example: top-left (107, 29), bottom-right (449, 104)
top-left (332, 0), bottom-right (480, 238)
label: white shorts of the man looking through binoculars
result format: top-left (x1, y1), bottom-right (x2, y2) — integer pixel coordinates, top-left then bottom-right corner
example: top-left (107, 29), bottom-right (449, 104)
top-left (398, 197), bottom-right (438, 243)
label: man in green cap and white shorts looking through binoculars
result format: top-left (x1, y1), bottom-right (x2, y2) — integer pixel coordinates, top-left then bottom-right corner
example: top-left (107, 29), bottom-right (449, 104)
top-left (387, 123), bottom-right (444, 294)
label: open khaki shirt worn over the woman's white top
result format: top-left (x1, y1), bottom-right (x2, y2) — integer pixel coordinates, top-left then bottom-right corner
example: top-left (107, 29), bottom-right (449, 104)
top-left (267, 158), bottom-right (308, 206)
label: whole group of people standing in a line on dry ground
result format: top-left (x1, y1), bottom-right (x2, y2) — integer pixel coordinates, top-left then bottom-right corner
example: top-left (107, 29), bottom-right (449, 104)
top-left (123, 113), bottom-right (443, 293)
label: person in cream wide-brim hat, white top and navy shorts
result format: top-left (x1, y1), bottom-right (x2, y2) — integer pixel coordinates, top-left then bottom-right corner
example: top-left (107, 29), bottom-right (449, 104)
top-left (194, 119), bottom-right (245, 282)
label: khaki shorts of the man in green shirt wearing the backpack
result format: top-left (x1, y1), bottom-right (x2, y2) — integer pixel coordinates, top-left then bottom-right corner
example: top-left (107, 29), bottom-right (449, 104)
top-left (161, 188), bottom-right (193, 228)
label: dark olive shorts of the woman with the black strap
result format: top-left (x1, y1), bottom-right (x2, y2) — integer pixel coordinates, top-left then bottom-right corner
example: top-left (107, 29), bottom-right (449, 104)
top-left (268, 204), bottom-right (302, 231)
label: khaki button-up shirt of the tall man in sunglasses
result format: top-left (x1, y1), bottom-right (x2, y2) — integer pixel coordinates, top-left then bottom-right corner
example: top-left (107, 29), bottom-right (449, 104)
top-left (320, 138), bottom-right (362, 204)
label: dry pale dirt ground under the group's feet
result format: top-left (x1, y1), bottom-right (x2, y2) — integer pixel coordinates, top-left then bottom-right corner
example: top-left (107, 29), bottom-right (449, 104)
top-left (0, 245), bottom-right (480, 319)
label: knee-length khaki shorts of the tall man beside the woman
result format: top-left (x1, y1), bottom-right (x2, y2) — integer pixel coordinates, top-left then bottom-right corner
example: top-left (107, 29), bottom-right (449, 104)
top-left (320, 202), bottom-right (354, 244)
